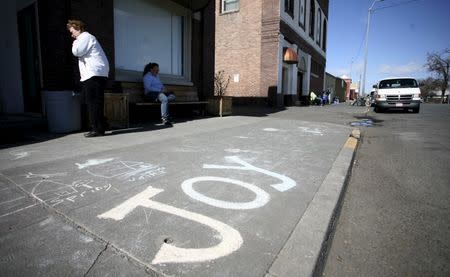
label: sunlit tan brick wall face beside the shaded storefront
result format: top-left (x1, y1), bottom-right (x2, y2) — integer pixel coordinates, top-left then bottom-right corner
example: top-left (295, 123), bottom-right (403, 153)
top-left (215, 0), bottom-right (266, 97)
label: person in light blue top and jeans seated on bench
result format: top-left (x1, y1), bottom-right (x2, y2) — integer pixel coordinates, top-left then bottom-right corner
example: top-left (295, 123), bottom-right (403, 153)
top-left (142, 63), bottom-right (175, 125)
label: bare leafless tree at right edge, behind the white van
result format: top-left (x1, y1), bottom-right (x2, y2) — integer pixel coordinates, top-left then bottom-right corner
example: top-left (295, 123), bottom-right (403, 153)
top-left (425, 48), bottom-right (450, 103)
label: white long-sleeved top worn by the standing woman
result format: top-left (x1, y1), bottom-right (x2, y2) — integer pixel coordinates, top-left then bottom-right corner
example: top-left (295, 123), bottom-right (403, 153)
top-left (72, 32), bottom-right (109, 82)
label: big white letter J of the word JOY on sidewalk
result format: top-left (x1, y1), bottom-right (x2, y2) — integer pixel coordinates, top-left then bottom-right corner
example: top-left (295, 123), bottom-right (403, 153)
top-left (97, 186), bottom-right (243, 264)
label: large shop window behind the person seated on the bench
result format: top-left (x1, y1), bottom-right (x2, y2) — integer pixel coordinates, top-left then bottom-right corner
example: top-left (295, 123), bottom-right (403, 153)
top-left (114, 0), bottom-right (190, 81)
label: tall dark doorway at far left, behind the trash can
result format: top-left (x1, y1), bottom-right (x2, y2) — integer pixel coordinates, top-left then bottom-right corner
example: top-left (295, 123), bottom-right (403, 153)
top-left (17, 4), bottom-right (42, 113)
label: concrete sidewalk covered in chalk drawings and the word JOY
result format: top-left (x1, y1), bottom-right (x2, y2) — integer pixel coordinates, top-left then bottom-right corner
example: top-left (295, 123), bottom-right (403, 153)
top-left (0, 105), bottom-right (365, 276)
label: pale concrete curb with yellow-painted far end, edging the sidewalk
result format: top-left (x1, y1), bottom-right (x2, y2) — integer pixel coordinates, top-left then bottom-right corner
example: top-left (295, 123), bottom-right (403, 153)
top-left (266, 129), bottom-right (361, 277)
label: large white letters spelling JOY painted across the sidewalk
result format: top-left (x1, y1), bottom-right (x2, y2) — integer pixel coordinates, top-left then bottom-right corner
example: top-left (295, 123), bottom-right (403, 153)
top-left (97, 156), bottom-right (297, 264)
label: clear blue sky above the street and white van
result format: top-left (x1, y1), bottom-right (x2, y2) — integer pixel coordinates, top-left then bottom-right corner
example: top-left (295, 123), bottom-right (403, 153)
top-left (326, 0), bottom-right (450, 93)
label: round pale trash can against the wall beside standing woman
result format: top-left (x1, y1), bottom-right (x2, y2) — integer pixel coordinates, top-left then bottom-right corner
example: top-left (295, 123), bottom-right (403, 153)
top-left (45, 90), bottom-right (81, 133)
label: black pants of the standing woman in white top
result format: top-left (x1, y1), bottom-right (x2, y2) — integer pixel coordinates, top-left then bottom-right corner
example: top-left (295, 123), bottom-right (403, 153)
top-left (82, 76), bottom-right (107, 133)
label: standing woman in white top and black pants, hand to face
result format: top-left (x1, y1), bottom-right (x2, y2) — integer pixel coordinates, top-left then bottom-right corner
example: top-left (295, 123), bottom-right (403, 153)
top-left (67, 20), bottom-right (109, 137)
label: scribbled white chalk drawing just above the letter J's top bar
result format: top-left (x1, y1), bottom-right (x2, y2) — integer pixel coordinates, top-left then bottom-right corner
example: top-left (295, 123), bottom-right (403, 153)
top-left (87, 161), bottom-right (166, 182)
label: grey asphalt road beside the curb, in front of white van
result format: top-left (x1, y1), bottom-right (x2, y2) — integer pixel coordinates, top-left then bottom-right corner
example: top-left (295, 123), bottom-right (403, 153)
top-left (323, 104), bottom-right (450, 276)
